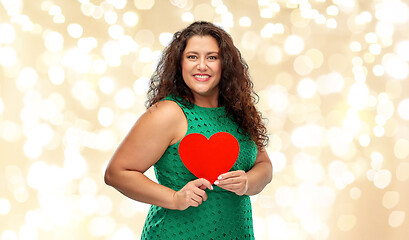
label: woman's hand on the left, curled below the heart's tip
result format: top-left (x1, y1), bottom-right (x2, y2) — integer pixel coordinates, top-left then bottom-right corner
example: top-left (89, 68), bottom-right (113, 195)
top-left (173, 178), bottom-right (213, 210)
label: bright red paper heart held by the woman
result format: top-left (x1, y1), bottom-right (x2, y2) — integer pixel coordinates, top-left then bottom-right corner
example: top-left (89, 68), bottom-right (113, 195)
top-left (179, 132), bottom-right (240, 184)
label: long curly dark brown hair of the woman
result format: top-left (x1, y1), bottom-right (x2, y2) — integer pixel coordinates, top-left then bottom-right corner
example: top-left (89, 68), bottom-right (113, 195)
top-left (146, 21), bottom-right (268, 149)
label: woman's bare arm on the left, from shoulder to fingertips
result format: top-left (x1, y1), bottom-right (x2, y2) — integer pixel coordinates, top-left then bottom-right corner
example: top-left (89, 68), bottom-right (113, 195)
top-left (105, 101), bottom-right (211, 210)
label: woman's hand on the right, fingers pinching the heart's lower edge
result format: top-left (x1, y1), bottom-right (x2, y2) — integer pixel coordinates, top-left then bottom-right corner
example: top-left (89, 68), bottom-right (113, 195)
top-left (214, 170), bottom-right (248, 196)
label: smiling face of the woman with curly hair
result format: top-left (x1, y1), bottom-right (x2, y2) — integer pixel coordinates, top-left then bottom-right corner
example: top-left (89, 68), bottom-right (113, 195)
top-left (181, 35), bottom-right (222, 98)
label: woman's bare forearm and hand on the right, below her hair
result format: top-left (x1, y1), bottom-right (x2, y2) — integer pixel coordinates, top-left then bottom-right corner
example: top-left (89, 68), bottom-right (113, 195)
top-left (215, 149), bottom-right (273, 195)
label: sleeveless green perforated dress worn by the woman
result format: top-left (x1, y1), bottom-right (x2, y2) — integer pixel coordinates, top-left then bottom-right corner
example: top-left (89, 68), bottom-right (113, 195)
top-left (141, 96), bottom-right (257, 240)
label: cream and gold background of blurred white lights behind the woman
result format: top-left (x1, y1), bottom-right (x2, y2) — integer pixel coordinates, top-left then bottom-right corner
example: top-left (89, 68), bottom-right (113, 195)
top-left (0, 0), bottom-right (409, 240)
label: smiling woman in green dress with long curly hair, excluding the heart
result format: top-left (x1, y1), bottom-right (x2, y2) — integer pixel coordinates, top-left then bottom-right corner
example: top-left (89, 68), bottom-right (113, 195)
top-left (105, 22), bottom-right (272, 239)
